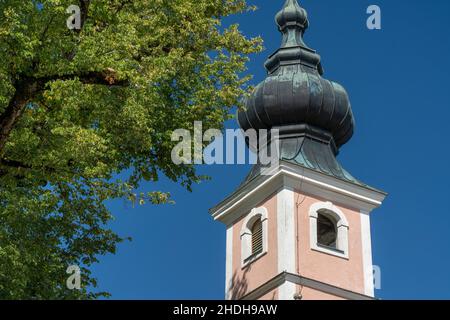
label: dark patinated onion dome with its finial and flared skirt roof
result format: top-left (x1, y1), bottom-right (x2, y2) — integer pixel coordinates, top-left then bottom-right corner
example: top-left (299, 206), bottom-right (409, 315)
top-left (237, 0), bottom-right (367, 187)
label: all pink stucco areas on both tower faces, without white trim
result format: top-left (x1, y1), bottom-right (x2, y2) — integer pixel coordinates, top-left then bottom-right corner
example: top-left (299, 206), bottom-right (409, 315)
top-left (231, 191), bottom-right (364, 300)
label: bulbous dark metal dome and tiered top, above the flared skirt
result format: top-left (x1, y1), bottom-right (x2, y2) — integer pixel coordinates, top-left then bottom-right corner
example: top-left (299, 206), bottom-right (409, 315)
top-left (238, 0), bottom-right (354, 149)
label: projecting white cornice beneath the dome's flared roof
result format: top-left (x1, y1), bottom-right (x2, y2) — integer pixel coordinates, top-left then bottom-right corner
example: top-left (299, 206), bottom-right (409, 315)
top-left (211, 162), bottom-right (386, 225)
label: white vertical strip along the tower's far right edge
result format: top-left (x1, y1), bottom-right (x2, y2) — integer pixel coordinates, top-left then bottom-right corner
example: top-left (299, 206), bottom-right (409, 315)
top-left (360, 211), bottom-right (375, 297)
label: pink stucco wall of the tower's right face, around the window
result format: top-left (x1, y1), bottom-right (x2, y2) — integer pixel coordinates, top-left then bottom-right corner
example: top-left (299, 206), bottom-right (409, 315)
top-left (294, 191), bottom-right (364, 293)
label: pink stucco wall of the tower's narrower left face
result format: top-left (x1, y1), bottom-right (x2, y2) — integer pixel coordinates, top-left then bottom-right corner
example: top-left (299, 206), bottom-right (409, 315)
top-left (231, 194), bottom-right (278, 300)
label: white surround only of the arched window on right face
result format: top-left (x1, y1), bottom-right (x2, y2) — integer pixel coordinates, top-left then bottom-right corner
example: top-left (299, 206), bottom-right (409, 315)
top-left (309, 201), bottom-right (349, 259)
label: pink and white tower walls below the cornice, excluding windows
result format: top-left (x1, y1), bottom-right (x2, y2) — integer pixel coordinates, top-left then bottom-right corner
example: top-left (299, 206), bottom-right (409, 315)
top-left (226, 187), bottom-right (373, 300)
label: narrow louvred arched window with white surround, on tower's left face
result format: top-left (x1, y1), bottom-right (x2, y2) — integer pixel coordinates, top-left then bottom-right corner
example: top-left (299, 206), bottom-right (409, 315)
top-left (241, 207), bottom-right (268, 267)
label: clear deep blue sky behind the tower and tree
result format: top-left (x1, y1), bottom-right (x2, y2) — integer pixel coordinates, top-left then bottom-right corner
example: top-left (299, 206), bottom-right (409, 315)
top-left (94, 0), bottom-right (450, 299)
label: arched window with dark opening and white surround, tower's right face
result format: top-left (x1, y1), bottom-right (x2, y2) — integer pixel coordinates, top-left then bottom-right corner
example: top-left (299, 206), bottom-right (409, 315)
top-left (309, 202), bottom-right (349, 259)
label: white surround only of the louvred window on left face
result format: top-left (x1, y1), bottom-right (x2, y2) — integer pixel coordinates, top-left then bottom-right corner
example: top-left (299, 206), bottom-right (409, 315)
top-left (240, 207), bottom-right (269, 268)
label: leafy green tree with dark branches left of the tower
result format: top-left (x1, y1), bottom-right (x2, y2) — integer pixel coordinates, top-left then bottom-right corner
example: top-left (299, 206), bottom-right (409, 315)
top-left (0, 0), bottom-right (261, 299)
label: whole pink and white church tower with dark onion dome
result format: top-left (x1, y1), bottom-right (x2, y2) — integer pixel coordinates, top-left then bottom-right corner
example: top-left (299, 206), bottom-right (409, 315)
top-left (211, 0), bottom-right (386, 300)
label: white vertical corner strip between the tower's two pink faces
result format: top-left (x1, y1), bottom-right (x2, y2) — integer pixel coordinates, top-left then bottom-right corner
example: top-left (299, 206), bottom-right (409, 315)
top-left (277, 188), bottom-right (297, 273)
